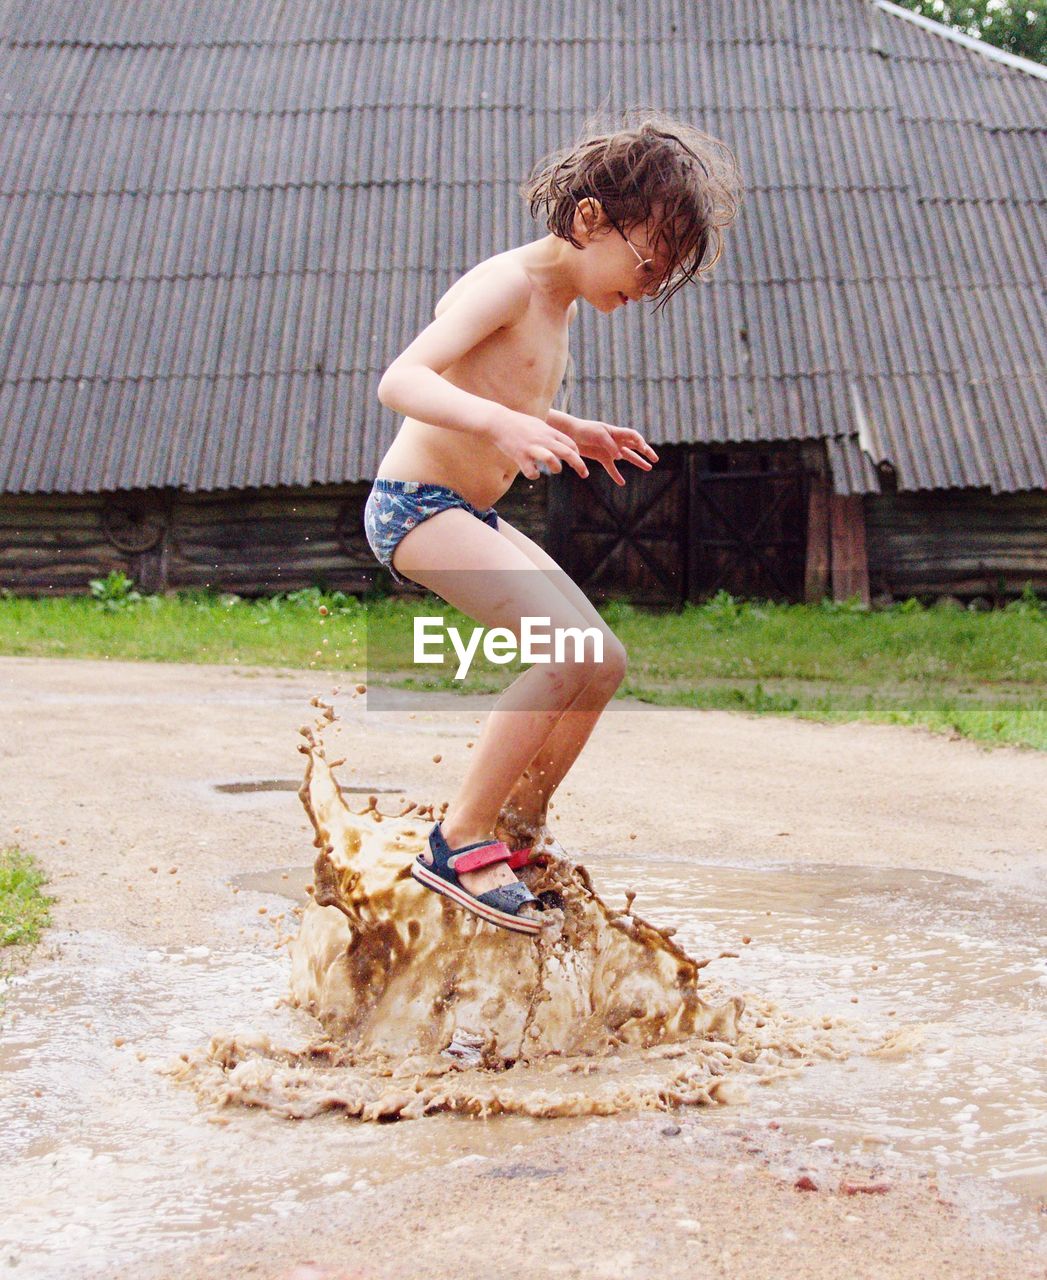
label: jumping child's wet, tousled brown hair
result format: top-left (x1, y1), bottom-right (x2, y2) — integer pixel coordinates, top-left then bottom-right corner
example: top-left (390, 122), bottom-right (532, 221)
top-left (522, 110), bottom-right (742, 306)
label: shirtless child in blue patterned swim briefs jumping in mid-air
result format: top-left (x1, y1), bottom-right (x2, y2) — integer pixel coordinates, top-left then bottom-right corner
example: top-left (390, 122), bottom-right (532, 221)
top-left (365, 113), bottom-right (739, 934)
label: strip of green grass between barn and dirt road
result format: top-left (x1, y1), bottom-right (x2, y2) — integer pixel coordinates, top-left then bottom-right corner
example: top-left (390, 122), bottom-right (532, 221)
top-left (0, 575), bottom-right (1047, 750)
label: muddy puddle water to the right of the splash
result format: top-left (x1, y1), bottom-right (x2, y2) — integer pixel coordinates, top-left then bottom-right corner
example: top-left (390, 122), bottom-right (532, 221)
top-left (230, 855), bottom-right (1047, 1201)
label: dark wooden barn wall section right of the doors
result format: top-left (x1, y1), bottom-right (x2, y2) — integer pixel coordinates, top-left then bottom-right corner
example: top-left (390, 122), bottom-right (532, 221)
top-left (865, 489), bottom-right (1047, 600)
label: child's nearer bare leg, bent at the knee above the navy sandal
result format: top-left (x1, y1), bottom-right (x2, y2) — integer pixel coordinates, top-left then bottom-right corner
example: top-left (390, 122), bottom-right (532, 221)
top-left (393, 508), bottom-right (621, 893)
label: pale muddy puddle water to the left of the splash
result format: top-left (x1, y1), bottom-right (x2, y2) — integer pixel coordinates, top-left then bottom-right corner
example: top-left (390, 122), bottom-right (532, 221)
top-left (0, 926), bottom-right (563, 1280)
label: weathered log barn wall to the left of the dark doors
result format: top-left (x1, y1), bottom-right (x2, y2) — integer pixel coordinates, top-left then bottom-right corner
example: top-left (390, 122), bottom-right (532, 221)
top-left (0, 480), bottom-right (545, 595)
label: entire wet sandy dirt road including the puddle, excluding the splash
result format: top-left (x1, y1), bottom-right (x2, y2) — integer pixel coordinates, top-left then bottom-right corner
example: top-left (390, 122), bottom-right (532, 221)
top-left (0, 659), bottom-right (1047, 1277)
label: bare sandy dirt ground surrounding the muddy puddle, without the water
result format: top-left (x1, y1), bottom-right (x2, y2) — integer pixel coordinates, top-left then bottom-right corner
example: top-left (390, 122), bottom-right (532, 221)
top-left (0, 658), bottom-right (1047, 1280)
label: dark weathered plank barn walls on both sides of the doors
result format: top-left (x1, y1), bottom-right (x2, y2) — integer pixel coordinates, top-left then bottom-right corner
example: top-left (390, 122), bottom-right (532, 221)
top-left (0, 480), bottom-right (1047, 599)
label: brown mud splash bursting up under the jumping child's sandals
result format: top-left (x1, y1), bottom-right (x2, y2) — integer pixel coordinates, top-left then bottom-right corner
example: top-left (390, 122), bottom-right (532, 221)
top-left (178, 699), bottom-right (852, 1120)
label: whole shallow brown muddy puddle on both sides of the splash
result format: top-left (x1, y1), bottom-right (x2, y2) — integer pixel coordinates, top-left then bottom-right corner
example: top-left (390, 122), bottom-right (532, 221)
top-left (0, 850), bottom-right (1047, 1280)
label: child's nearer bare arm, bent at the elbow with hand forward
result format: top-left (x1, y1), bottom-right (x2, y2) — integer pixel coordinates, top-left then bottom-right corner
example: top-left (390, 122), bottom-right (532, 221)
top-left (378, 266), bottom-right (589, 480)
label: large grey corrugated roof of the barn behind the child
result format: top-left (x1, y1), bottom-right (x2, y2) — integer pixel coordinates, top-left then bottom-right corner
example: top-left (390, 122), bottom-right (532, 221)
top-left (0, 0), bottom-right (1047, 493)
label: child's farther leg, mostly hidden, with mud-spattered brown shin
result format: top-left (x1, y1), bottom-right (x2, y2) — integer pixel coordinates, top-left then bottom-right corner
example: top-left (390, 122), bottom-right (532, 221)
top-left (498, 516), bottom-right (626, 842)
